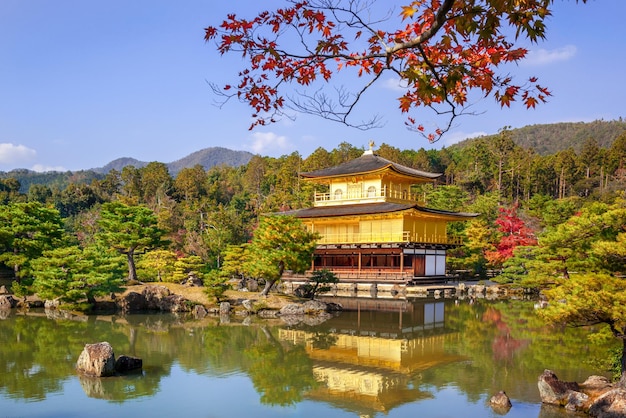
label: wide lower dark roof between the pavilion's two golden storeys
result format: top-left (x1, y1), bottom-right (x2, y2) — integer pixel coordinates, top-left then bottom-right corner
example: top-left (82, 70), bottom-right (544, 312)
top-left (280, 202), bottom-right (479, 219)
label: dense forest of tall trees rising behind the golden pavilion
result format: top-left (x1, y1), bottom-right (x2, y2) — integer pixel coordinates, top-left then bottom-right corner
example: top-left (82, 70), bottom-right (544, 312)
top-left (0, 119), bottom-right (626, 280)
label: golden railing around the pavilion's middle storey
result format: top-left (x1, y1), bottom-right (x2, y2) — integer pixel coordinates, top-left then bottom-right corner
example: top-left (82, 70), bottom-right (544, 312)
top-left (317, 231), bottom-right (462, 245)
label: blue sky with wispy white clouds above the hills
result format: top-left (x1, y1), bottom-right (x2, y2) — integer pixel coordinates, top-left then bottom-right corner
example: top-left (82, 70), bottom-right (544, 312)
top-left (0, 0), bottom-right (626, 171)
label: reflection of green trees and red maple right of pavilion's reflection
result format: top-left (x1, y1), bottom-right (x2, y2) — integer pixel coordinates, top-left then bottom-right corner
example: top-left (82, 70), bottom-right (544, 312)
top-left (415, 300), bottom-right (606, 402)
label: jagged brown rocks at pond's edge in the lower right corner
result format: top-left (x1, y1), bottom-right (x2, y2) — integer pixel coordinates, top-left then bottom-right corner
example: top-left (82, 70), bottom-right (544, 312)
top-left (538, 370), bottom-right (626, 418)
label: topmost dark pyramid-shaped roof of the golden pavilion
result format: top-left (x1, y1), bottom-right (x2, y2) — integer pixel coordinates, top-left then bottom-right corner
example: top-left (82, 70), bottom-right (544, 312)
top-left (300, 153), bottom-right (441, 179)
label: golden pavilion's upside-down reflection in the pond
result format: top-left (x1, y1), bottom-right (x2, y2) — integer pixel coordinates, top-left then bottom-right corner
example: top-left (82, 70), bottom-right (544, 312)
top-left (279, 299), bottom-right (464, 415)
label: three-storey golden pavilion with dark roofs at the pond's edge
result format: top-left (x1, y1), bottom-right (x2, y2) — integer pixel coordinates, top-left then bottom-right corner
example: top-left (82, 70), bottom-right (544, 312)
top-left (287, 143), bottom-right (478, 283)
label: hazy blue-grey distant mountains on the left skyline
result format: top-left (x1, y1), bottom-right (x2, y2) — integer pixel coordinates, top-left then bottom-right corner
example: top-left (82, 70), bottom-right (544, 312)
top-left (91, 147), bottom-right (253, 176)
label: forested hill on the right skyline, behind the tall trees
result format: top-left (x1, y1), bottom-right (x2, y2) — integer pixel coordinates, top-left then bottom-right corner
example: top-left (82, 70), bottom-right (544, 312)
top-left (456, 118), bottom-right (626, 156)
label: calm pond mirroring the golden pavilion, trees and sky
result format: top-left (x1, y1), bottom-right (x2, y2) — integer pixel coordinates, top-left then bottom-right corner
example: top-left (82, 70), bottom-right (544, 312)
top-left (0, 299), bottom-right (607, 418)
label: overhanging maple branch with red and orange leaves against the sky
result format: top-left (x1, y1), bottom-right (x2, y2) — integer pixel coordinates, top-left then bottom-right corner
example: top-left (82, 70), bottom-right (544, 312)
top-left (205, 0), bottom-right (552, 141)
